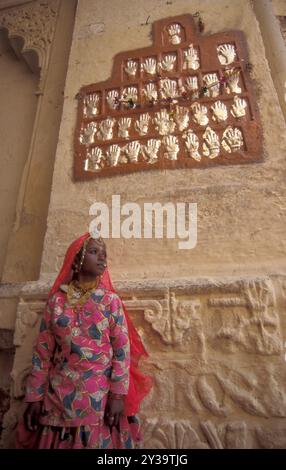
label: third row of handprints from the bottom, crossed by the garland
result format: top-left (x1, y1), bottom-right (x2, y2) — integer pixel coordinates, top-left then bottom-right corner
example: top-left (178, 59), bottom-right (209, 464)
top-left (84, 68), bottom-right (242, 118)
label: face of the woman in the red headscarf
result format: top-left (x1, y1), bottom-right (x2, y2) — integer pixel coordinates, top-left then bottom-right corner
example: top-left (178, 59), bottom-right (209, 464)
top-left (81, 238), bottom-right (106, 277)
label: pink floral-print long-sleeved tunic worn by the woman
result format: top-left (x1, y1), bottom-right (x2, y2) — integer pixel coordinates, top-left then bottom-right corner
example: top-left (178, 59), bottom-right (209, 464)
top-left (26, 288), bottom-right (130, 430)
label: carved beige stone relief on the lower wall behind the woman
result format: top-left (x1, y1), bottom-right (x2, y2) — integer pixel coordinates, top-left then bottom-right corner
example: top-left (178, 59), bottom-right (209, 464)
top-left (2, 278), bottom-right (286, 449)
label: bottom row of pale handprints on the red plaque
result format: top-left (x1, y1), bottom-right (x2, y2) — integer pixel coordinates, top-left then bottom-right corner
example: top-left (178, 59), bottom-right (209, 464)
top-left (84, 126), bottom-right (245, 171)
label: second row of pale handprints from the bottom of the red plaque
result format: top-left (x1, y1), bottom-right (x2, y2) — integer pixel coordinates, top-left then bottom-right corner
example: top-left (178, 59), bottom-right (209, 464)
top-left (79, 96), bottom-right (247, 146)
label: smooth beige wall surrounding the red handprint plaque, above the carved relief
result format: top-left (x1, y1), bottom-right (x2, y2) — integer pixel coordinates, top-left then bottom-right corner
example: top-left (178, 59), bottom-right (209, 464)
top-left (41, 0), bottom-right (286, 279)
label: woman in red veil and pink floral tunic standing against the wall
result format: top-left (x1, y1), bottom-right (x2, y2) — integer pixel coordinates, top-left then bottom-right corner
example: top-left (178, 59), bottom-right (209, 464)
top-left (17, 233), bottom-right (152, 449)
